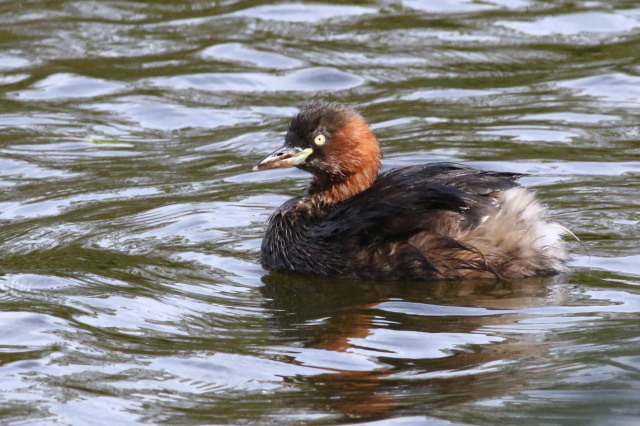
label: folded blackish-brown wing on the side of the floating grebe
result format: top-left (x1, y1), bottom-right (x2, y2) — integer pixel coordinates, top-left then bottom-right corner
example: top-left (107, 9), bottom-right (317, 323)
top-left (317, 163), bottom-right (522, 244)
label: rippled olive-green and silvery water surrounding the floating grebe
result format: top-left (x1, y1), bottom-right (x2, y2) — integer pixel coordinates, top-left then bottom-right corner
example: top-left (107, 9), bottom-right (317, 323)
top-left (0, 0), bottom-right (640, 425)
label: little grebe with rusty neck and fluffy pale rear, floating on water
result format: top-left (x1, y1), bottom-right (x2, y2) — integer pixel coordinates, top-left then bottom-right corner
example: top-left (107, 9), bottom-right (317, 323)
top-left (254, 102), bottom-right (570, 280)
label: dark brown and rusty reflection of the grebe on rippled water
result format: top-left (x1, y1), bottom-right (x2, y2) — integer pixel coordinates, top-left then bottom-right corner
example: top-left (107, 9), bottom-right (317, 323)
top-left (262, 272), bottom-right (570, 420)
